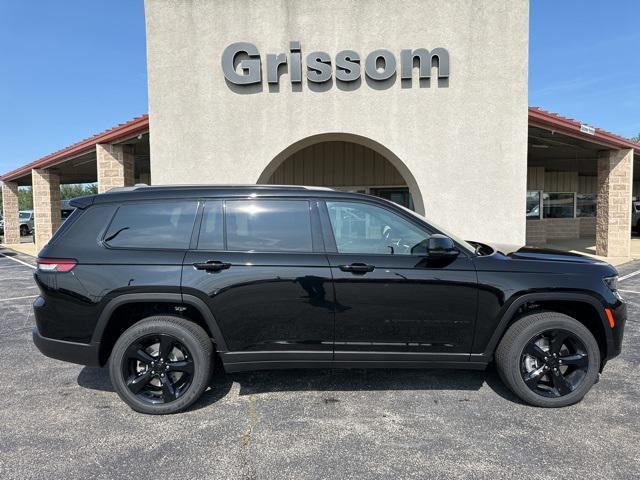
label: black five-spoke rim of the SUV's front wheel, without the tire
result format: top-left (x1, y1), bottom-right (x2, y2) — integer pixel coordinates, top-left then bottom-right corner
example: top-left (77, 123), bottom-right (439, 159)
top-left (520, 329), bottom-right (589, 397)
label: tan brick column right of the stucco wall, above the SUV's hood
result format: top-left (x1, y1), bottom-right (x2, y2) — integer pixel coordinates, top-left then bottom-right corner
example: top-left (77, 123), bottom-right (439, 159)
top-left (596, 149), bottom-right (633, 257)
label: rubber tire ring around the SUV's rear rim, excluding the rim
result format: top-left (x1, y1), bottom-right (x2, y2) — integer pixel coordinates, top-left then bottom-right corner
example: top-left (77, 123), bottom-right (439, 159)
top-left (109, 317), bottom-right (211, 414)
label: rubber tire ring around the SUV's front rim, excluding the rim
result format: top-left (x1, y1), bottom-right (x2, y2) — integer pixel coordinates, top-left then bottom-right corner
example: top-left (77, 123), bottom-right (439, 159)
top-left (502, 313), bottom-right (600, 407)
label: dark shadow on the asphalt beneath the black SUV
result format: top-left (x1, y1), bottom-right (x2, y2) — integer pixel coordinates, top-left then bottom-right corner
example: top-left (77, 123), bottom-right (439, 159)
top-left (78, 366), bottom-right (522, 410)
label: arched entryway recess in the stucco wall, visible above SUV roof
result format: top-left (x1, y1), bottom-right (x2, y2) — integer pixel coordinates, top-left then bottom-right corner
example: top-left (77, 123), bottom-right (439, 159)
top-left (258, 134), bottom-right (424, 213)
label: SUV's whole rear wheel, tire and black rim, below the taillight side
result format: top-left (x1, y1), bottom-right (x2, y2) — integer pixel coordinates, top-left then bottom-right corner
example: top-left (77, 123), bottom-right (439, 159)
top-left (109, 316), bottom-right (213, 415)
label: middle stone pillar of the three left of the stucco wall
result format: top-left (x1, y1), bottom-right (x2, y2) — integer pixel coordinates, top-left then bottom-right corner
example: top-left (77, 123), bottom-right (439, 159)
top-left (31, 168), bottom-right (62, 250)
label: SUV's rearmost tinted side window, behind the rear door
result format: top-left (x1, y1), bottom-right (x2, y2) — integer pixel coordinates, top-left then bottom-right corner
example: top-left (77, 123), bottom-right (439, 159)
top-left (104, 201), bottom-right (198, 249)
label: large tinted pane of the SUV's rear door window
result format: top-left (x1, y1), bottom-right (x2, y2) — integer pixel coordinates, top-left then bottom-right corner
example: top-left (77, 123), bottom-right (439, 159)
top-left (226, 200), bottom-right (313, 252)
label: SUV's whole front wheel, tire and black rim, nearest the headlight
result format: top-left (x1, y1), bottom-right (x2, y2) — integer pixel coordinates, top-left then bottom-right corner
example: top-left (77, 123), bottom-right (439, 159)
top-left (495, 312), bottom-right (600, 407)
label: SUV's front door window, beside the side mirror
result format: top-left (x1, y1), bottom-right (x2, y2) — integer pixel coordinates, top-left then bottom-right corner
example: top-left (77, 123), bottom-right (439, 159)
top-left (327, 202), bottom-right (429, 255)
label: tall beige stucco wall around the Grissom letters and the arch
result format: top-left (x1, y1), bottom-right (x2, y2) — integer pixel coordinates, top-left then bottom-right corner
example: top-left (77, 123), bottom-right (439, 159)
top-left (145, 0), bottom-right (529, 243)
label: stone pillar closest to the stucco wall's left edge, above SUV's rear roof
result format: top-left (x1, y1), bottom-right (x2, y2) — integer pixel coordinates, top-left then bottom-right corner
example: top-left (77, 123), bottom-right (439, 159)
top-left (96, 143), bottom-right (135, 193)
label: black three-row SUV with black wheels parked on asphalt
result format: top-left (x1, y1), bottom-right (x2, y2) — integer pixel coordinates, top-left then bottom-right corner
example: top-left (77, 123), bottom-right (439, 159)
top-left (33, 185), bottom-right (626, 413)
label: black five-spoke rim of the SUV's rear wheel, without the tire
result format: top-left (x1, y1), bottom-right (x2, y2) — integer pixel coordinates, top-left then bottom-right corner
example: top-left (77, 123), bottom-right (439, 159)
top-left (122, 334), bottom-right (194, 404)
